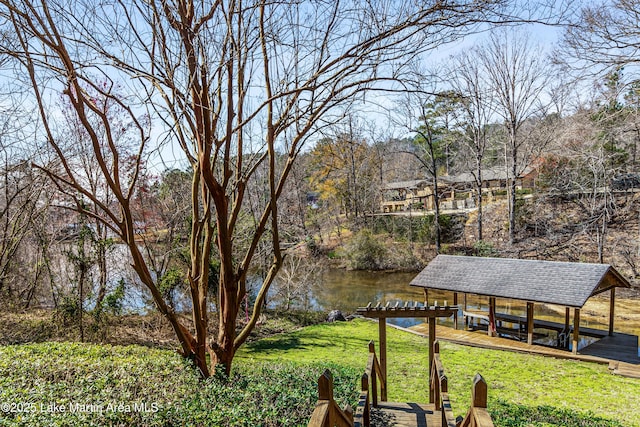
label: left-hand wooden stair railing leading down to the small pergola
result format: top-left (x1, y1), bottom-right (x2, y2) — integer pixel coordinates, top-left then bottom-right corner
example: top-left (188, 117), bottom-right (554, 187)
top-left (354, 341), bottom-right (387, 427)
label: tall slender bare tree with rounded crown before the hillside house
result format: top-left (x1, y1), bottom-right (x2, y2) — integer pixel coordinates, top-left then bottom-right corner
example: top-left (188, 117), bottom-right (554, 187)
top-left (478, 30), bottom-right (550, 244)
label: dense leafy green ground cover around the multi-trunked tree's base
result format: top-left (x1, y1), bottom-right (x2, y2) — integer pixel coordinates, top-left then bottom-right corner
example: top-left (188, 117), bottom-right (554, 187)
top-left (0, 343), bottom-right (359, 427)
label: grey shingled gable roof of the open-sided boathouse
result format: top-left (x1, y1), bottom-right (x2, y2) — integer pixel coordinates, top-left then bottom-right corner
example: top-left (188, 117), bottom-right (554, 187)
top-left (410, 255), bottom-right (630, 308)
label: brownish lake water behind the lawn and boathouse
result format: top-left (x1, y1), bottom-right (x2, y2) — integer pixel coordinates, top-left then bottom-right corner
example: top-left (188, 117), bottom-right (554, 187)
top-left (122, 269), bottom-right (640, 347)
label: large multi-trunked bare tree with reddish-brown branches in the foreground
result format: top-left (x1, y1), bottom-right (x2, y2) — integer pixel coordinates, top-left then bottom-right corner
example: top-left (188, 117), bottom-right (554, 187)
top-left (0, 0), bottom-right (540, 376)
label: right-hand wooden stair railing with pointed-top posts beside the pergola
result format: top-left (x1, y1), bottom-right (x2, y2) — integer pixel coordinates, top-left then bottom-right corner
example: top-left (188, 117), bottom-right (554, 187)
top-left (429, 341), bottom-right (493, 427)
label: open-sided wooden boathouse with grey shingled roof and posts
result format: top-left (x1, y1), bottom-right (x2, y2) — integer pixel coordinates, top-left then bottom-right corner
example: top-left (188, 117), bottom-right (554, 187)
top-left (410, 255), bottom-right (630, 353)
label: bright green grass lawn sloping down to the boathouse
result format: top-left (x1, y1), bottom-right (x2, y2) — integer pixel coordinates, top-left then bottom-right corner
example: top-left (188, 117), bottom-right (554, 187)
top-left (237, 320), bottom-right (640, 427)
